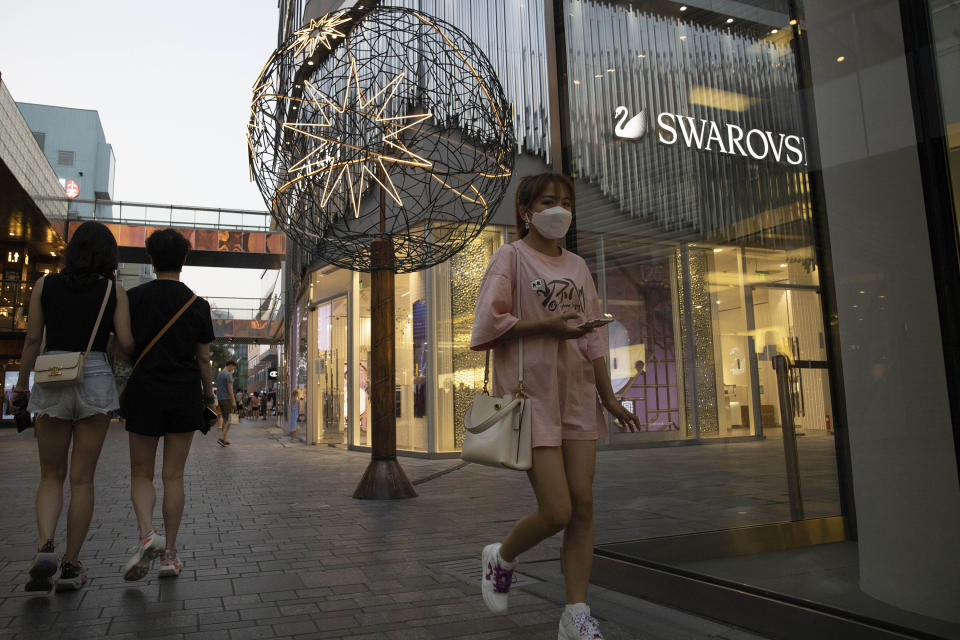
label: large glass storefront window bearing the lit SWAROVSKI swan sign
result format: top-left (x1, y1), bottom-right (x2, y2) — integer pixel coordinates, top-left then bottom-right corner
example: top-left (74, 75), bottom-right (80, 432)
top-left (558, 0), bottom-right (960, 637)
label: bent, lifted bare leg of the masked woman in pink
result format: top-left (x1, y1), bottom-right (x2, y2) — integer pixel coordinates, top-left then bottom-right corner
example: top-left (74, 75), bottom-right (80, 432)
top-left (500, 447), bottom-right (571, 562)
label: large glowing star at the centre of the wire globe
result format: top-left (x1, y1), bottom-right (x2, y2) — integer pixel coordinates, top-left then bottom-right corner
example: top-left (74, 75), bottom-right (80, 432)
top-left (277, 63), bottom-right (433, 218)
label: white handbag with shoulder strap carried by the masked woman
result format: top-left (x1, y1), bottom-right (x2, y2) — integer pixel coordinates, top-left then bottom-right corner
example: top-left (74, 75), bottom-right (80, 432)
top-left (460, 247), bottom-right (533, 471)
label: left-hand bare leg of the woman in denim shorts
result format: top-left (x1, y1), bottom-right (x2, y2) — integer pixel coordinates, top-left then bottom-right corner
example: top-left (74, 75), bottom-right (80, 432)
top-left (36, 416), bottom-right (73, 546)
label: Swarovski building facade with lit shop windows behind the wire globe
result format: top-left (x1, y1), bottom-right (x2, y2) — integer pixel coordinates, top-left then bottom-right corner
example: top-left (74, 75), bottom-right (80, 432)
top-left (281, 0), bottom-right (960, 637)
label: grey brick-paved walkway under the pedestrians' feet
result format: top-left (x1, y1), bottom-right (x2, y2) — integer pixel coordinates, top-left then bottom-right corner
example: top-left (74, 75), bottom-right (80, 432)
top-left (0, 422), bottom-right (772, 640)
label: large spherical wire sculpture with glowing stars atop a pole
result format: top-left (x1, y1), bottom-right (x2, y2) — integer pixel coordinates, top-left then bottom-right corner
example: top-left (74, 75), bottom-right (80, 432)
top-left (248, 7), bottom-right (516, 273)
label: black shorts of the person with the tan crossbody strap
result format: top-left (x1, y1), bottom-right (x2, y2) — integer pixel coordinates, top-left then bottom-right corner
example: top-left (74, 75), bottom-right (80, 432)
top-left (123, 380), bottom-right (206, 437)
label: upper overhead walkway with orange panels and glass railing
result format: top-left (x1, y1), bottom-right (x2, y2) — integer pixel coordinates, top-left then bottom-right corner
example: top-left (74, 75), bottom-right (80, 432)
top-left (50, 199), bottom-right (286, 269)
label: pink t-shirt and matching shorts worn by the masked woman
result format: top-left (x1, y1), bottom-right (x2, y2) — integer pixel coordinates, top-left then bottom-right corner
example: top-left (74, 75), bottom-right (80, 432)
top-left (470, 240), bottom-right (609, 447)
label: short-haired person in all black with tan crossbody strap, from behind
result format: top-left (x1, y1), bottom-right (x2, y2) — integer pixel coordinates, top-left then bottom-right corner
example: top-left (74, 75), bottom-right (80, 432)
top-left (121, 229), bottom-right (217, 580)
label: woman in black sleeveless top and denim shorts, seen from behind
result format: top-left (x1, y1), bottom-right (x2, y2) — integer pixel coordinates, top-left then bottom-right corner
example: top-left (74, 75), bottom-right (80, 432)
top-left (13, 222), bottom-right (133, 591)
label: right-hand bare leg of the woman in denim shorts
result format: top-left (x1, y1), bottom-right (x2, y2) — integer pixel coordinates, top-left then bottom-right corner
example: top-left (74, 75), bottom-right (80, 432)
top-left (63, 413), bottom-right (110, 564)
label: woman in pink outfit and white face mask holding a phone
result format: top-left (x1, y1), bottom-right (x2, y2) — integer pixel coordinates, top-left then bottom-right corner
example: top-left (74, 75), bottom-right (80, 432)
top-left (470, 173), bottom-right (640, 640)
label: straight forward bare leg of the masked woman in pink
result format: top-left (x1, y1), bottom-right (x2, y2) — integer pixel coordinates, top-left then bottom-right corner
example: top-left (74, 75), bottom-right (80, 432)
top-left (563, 440), bottom-right (597, 604)
